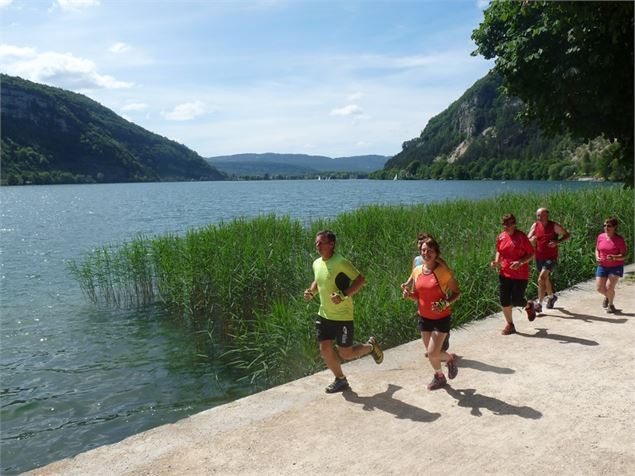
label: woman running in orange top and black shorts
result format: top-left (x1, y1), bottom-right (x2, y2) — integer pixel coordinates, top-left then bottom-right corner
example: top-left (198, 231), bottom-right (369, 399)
top-left (403, 237), bottom-right (461, 390)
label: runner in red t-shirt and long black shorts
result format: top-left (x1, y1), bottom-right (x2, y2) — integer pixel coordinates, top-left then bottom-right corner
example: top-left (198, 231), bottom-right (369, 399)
top-left (490, 213), bottom-right (536, 336)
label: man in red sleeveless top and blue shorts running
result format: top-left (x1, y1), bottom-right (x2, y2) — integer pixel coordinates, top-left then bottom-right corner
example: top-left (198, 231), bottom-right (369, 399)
top-left (527, 207), bottom-right (571, 312)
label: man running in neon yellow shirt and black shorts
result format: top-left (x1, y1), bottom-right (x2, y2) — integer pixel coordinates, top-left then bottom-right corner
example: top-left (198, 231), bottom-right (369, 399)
top-left (304, 230), bottom-right (384, 393)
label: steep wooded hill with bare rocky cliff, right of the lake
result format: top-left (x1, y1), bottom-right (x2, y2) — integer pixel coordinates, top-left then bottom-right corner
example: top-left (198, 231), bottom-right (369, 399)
top-left (380, 73), bottom-right (616, 180)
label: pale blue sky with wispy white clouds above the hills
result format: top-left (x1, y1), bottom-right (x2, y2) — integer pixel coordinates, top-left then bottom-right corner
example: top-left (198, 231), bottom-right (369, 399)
top-left (0, 0), bottom-right (493, 157)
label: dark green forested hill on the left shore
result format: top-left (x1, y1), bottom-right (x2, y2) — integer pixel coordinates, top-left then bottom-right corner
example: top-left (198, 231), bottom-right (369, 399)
top-left (0, 74), bottom-right (224, 184)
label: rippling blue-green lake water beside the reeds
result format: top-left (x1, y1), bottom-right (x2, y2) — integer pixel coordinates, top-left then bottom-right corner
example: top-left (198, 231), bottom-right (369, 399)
top-left (0, 180), bottom-right (608, 474)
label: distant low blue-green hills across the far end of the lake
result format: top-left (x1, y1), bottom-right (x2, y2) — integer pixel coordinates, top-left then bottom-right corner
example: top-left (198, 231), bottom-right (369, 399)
top-left (206, 153), bottom-right (389, 177)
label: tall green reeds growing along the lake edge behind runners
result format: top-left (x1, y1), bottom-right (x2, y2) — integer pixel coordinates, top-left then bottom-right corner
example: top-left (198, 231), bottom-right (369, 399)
top-left (70, 187), bottom-right (633, 386)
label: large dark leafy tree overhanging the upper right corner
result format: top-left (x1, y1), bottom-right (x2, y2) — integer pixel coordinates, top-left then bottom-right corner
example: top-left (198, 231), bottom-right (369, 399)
top-left (472, 0), bottom-right (633, 186)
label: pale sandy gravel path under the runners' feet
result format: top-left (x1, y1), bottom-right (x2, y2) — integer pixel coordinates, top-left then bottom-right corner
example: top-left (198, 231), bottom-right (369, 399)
top-left (29, 265), bottom-right (635, 476)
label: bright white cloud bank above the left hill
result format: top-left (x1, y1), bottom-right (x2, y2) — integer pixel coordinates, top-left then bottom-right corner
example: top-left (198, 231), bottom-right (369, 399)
top-left (0, 45), bottom-right (133, 90)
